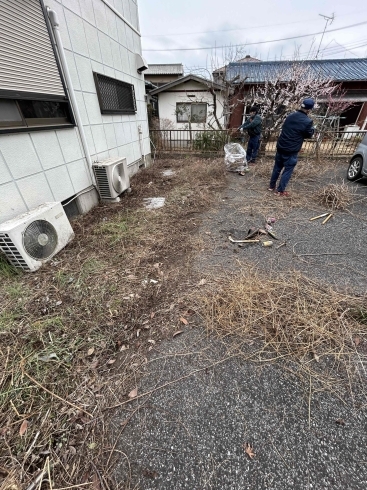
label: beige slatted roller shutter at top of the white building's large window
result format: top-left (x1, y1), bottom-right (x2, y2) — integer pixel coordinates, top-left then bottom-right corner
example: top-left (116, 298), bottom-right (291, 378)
top-left (0, 0), bottom-right (65, 96)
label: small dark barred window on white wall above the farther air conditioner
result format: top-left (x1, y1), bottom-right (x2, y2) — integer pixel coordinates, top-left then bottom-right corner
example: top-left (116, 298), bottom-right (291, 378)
top-left (93, 73), bottom-right (136, 114)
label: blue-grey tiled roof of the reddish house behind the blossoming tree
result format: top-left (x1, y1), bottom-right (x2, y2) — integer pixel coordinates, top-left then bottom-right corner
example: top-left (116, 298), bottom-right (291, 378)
top-left (226, 58), bottom-right (367, 83)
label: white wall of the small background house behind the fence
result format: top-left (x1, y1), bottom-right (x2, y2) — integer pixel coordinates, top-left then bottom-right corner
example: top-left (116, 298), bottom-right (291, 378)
top-left (157, 80), bottom-right (224, 129)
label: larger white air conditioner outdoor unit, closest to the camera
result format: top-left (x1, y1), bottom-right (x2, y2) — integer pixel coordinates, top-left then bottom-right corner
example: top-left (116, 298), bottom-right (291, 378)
top-left (0, 202), bottom-right (74, 272)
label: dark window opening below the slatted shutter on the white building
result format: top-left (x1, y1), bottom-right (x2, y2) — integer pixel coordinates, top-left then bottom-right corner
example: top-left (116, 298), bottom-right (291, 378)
top-left (0, 98), bottom-right (73, 130)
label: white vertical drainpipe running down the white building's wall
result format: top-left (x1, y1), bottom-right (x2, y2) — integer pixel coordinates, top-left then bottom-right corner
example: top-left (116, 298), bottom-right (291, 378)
top-left (46, 7), bottom-right (96, 186)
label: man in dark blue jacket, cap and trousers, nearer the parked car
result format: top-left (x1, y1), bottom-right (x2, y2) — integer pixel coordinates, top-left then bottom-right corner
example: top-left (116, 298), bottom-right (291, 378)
top-left (269, 99), bottom-right (315, 196)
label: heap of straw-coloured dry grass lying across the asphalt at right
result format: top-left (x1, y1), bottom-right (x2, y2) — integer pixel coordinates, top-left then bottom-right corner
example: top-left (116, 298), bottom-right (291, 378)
top-left (194, 266), bottom-right (367, 392)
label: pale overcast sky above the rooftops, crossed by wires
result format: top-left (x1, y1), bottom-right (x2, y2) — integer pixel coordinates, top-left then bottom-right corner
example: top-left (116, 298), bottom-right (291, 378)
top-left (138, 0), bottom-right (367, 74)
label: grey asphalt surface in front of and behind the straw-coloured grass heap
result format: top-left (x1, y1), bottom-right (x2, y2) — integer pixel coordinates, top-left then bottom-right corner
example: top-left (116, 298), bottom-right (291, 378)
top-left (115, 159), bottom-right (367, 490)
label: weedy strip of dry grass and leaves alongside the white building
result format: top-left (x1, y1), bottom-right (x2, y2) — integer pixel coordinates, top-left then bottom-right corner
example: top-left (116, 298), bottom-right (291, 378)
top-left (0, 159), bottom-right (225, 490)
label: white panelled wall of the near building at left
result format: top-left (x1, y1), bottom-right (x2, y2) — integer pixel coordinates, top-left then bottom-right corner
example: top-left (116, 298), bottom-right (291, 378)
top-left (0, 0), bottom-right (150, 223)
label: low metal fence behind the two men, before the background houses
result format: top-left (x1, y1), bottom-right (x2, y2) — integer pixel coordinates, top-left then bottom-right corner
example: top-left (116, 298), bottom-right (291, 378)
top-left (150, 129), bottom-right (367, 158)
